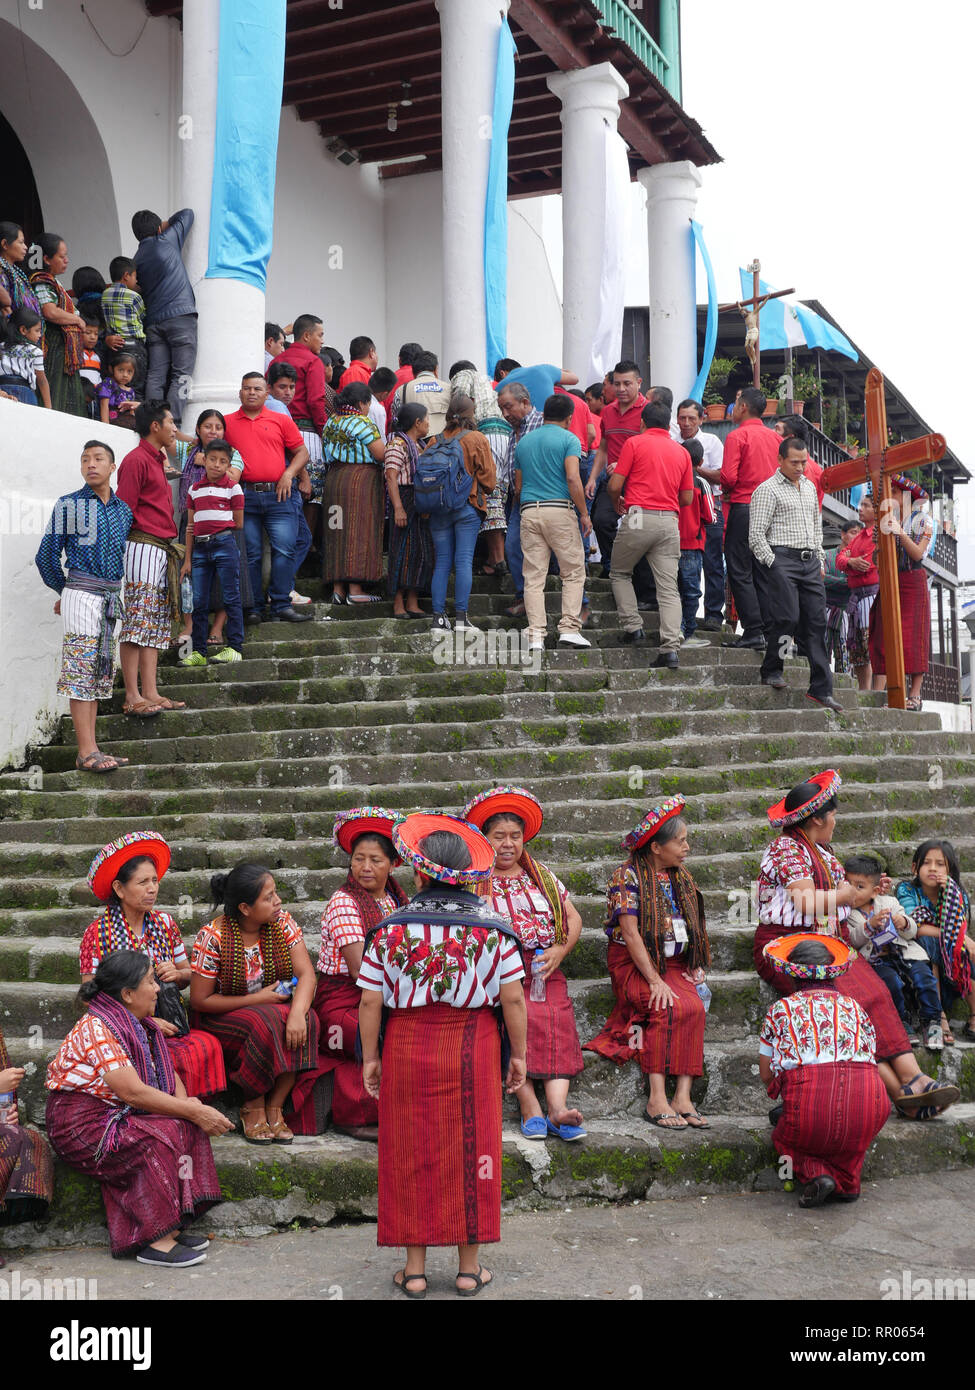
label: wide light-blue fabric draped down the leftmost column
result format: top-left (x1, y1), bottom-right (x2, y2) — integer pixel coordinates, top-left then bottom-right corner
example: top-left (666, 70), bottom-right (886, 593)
top-left (206, 0), bottom-right (285, 291)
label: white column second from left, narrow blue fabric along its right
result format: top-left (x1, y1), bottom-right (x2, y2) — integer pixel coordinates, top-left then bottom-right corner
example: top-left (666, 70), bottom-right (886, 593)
top-left (437, 0), bottom-right (510, 375)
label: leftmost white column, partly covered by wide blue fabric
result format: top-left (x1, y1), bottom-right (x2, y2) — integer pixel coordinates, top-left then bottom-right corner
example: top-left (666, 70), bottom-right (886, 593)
top-left (179, 0), bottom-right (264, 419)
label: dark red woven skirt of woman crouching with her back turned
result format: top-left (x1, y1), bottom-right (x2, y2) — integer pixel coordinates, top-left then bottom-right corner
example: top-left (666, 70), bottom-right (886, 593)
top-left (772, 1062), bottom-right (890, 1194)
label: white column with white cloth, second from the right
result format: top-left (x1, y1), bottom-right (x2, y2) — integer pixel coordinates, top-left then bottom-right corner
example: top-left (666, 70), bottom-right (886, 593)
top-left (545, 63), bottom-right (630, 381)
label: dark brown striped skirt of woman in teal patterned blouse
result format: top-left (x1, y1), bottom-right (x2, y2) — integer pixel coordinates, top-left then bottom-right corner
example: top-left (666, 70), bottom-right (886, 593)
top-left (321, 463), bottom-right (385, 584)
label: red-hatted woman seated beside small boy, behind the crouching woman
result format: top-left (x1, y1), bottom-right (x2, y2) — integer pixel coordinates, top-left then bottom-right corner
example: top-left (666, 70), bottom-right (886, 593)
top-left (752, 769), bottom-right (961, 1119)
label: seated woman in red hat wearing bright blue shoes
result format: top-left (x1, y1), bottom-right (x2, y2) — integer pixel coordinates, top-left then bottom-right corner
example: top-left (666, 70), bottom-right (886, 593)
top-left (462, 787), bottom-right (586, 1140)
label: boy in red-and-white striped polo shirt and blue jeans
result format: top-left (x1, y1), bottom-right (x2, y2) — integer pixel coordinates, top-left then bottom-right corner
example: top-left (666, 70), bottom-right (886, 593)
top-left (179, 439), bottom-right (243, 666)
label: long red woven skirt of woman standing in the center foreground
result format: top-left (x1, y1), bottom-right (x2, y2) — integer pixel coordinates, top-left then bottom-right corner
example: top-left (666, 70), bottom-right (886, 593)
top-left (377, 1004), bottom-right (501, 1245)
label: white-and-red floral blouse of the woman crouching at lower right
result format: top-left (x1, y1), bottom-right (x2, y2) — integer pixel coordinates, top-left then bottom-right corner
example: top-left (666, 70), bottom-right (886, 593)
top-left (758, 990), bottom-right (876, 1076)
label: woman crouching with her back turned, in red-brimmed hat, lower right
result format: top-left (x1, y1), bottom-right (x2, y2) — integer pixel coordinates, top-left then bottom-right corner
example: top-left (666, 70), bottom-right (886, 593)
top-left (758, 933), bottom-right (890, 1207)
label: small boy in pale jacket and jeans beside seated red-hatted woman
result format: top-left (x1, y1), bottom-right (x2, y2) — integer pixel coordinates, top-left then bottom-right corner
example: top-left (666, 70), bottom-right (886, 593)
top-left (843, 855), bottom-right (944, 1052)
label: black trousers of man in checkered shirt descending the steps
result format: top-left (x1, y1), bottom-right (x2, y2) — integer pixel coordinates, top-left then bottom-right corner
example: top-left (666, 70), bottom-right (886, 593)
top-left (755, 549), bottom-right (833, 699)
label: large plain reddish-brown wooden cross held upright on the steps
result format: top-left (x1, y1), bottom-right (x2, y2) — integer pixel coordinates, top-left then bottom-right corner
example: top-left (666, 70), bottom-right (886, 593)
top-left (822, 367), bottom-right (947, 709)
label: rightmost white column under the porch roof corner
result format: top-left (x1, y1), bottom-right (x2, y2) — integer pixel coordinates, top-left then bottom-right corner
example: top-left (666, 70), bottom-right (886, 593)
top-left (637, 160), bottom-right (701, 402)
